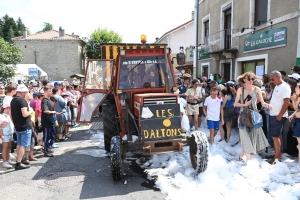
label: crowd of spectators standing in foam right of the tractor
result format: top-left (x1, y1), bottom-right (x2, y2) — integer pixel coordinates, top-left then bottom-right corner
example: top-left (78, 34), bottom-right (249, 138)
top-left (178, 66), bottom-right (300, 166)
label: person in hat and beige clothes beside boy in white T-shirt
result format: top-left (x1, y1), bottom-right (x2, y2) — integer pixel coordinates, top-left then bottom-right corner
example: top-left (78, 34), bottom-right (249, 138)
top-left (186, 79), bottom-right (202, 131)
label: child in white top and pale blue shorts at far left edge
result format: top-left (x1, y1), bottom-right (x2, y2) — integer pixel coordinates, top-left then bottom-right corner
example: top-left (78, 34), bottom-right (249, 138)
top-left (0, 103), bottom-right (16, 168)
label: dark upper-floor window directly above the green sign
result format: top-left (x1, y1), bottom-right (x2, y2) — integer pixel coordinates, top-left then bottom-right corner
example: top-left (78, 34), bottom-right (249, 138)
top-left (254, 0), bottom-right (268, 26)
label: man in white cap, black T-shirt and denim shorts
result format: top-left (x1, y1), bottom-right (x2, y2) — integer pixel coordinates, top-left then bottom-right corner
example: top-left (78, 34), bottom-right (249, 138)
top-left (10, 84), bottom-right (34, 170)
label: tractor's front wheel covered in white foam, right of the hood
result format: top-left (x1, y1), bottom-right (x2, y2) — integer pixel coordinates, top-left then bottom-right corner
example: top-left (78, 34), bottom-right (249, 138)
top-left (190, 131), bottom-right (208, 174)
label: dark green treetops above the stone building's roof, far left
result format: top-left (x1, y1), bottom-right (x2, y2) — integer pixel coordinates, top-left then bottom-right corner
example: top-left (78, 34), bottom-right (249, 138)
top-left (0, 14), bottom-right (25, 42)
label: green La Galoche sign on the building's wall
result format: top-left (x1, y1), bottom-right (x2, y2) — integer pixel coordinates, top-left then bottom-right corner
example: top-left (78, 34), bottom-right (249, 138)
top-left (244, 27), bottom-right (287, 53)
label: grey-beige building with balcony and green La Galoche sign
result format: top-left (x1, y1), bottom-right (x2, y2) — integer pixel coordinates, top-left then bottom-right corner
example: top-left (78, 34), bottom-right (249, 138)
top-left (193, 0), bottom-right (300, 81)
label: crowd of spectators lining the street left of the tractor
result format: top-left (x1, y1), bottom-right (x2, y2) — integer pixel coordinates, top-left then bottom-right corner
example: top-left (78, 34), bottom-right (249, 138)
top-left (0, 79), bottom-right (81, 170)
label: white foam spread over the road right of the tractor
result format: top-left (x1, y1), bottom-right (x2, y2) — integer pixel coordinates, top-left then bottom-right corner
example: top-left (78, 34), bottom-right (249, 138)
top-left (143, 126), bottom-right (300, 200)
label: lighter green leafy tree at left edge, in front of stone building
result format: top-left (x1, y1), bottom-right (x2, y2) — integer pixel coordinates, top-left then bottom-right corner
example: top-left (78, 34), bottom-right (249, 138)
top-left (0, 38), bottom-right (23, 82)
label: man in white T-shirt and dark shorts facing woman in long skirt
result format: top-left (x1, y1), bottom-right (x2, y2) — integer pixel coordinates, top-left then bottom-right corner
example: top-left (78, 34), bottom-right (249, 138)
top-left (268, 70), bottom-right (291, 164)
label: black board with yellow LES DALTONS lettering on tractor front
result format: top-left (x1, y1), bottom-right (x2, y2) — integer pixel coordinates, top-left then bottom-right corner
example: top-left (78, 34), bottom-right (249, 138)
top-left (140, 103), bottom-right (182, 141)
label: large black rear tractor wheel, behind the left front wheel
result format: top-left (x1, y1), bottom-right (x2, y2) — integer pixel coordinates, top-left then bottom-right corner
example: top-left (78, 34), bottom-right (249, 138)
top-left (102, 102), bottom-right (120, 152)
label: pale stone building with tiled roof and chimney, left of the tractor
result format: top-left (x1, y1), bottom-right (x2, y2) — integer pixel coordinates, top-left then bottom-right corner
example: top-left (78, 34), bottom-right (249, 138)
top-left (12, 27), bottom-right (86, 81)
